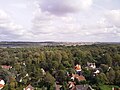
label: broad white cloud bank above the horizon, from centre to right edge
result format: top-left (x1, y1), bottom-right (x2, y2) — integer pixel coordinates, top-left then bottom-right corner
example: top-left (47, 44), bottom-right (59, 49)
top-left (32, 2), bottom-right (120, 41)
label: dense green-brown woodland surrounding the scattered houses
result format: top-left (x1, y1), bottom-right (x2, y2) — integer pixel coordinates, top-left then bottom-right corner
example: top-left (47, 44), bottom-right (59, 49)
top-left (0, 44), bottom-right (120, 90)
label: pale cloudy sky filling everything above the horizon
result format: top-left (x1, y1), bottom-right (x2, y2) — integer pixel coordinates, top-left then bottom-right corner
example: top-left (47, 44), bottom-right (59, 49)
top-left (0, 0), bottom-right (120, 42)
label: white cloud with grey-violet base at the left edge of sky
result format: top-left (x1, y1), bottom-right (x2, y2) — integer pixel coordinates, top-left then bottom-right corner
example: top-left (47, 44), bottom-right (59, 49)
top-left (0, 10), bottom-right (33, 40)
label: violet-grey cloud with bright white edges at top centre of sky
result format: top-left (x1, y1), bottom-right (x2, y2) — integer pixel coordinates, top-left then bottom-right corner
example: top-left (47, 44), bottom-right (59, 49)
top-left (38, 0), bottom-right (93, 15)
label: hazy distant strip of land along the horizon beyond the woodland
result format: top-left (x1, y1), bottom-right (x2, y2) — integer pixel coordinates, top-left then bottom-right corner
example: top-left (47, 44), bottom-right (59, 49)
top-left (0, 41), bottom-right (120, 48)
